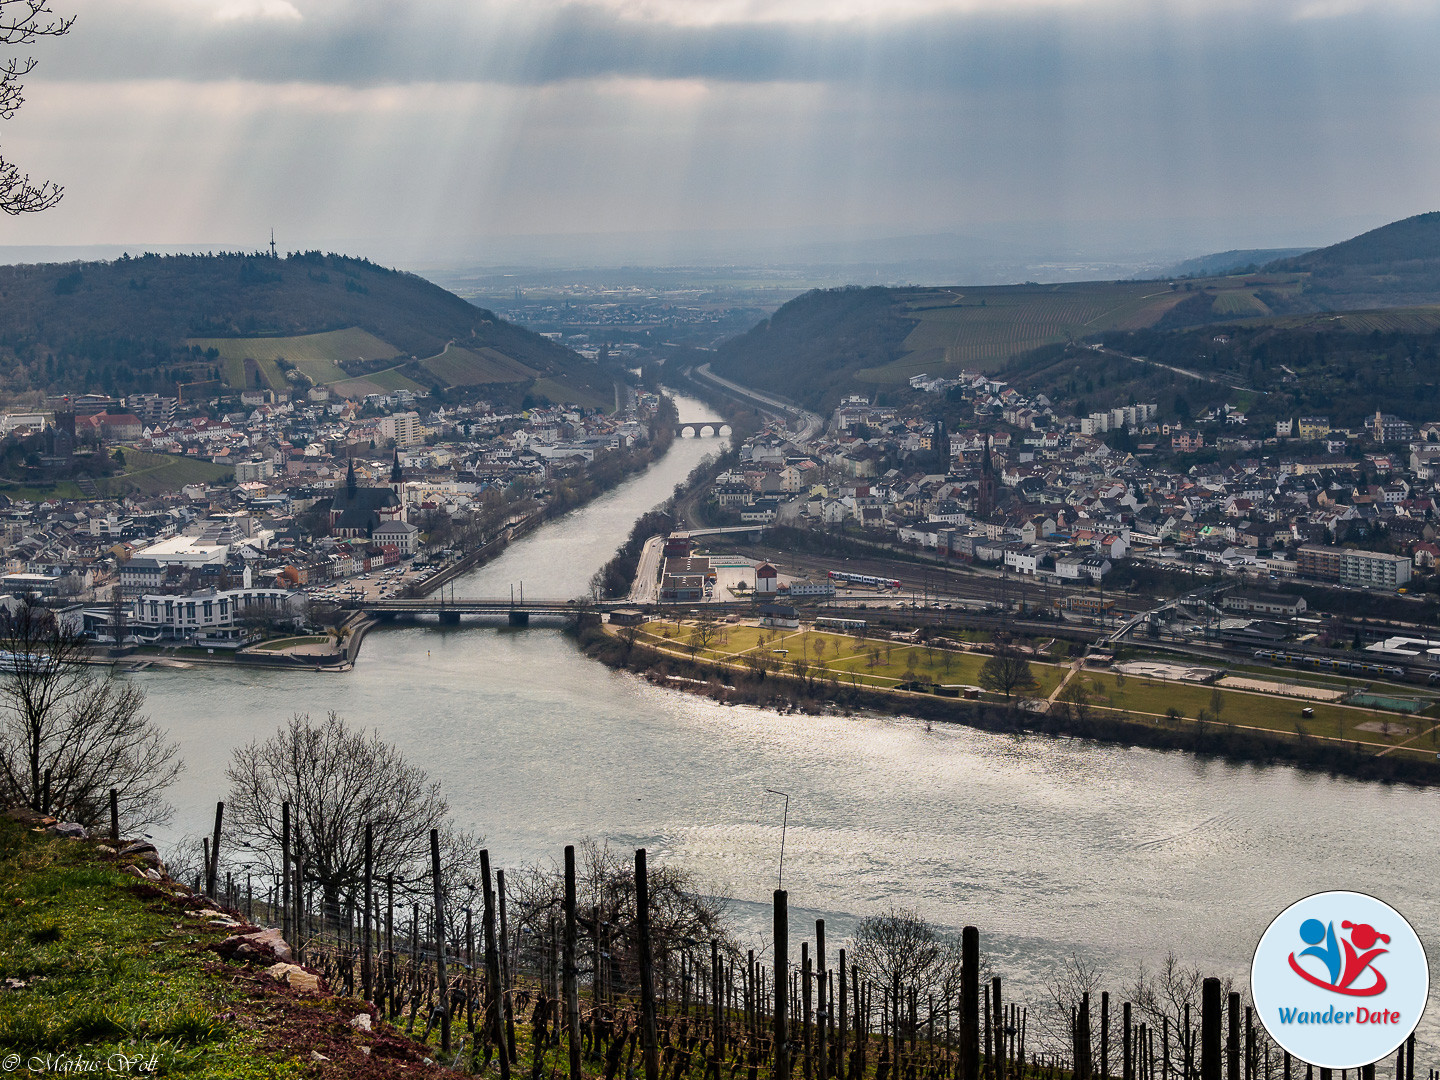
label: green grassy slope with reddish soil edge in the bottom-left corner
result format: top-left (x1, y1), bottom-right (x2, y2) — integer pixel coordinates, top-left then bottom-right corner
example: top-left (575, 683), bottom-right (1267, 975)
top-left (0, 818), bottom-right (449, 1080)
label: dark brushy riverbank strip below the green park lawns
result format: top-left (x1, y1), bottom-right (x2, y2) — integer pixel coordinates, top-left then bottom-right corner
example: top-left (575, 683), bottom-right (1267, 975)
top-left (579, 625), bottom-right (1440, 786)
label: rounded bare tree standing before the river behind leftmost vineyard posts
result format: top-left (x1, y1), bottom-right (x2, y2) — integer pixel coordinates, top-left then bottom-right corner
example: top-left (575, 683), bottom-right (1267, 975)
top-left (226, 713), bottom-right (475, 910)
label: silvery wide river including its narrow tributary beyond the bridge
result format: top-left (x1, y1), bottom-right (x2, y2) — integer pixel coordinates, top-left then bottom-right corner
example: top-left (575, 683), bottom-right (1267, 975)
top-left (134, 399), bottom-right (1440, 1064)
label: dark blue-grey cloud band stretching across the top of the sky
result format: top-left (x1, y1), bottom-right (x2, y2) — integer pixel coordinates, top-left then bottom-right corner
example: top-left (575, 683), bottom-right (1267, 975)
top-left (45, 0), bottom-right (1440, 105)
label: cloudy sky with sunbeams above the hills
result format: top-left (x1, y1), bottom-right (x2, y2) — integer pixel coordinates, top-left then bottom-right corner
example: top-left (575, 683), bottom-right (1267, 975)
top-left (0, 0), bottom-right (1440, 269)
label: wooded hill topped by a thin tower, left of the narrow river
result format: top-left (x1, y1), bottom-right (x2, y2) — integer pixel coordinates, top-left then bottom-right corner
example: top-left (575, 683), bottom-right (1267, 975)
top-left (0, 252), bottom-right (615, 406)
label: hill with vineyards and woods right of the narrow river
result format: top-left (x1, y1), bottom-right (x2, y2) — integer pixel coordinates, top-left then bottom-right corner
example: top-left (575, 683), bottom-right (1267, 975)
top-left (711, 213), bottom-right (1440, 423)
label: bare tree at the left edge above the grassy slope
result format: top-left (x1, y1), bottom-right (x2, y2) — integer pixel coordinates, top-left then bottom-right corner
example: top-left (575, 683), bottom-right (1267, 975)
top-left (0, 603), bottom-right (183, 828)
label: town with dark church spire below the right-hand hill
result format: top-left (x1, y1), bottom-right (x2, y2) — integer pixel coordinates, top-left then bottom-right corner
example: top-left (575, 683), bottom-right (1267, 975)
top-left (710, 373), bottom-right (1440, 589)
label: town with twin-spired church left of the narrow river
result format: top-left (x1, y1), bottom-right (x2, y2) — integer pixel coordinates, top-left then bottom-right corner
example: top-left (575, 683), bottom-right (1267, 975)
top-left (0, 390), bottom-right (672, 649)
